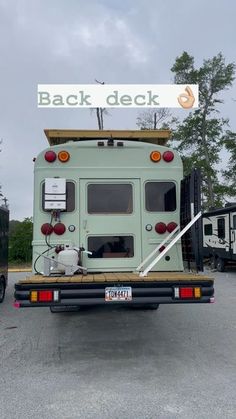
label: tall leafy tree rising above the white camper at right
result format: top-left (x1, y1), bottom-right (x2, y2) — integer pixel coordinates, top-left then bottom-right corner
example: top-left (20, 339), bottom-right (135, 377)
top-left (171, 52), bottom-right (235, 208)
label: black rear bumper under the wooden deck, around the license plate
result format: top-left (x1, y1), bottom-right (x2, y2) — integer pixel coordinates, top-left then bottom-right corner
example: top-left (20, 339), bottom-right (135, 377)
top-left (15, 280), bottom-right (214, 307)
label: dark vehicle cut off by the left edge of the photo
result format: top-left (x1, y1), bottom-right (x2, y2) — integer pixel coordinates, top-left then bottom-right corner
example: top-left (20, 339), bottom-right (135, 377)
top-left (0, 207), bottom-right (9, 303)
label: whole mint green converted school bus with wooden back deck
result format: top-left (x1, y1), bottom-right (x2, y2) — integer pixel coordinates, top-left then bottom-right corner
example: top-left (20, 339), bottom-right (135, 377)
top-left (15, 129), bottom-right (214, 310)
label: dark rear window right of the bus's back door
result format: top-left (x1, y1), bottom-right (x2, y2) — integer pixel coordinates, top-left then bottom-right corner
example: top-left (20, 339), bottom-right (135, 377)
top-left (145, 182), bottom-right (176, 212)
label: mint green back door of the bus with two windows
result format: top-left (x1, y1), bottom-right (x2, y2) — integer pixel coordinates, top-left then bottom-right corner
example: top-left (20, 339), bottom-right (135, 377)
top-left (79, 179), bottom-right (142, 271)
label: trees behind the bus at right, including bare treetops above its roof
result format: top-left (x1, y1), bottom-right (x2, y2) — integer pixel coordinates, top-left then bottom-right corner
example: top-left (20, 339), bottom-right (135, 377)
top-left (137, 52), bottom-right (236, 210)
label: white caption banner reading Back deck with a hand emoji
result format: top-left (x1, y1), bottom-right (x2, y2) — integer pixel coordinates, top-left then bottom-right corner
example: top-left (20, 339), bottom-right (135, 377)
top-left (38, 84), bottom-right (198, 109)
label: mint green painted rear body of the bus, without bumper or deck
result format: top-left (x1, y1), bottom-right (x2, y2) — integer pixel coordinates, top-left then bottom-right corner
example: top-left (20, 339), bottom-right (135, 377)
top-left (33, 135), bottom-right (183, 272)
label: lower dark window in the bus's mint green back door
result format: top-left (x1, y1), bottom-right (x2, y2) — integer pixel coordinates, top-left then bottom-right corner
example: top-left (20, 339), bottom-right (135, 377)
top-left (88, 236), bottom-right (134, 258)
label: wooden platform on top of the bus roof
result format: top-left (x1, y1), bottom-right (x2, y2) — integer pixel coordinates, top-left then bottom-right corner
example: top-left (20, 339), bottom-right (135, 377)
top-left (44, 129), bottom-right (171, 146)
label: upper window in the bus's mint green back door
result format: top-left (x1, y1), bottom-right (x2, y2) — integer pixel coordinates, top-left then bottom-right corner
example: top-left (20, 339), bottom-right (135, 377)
top-left (88, 183), bottom-right (133, 214)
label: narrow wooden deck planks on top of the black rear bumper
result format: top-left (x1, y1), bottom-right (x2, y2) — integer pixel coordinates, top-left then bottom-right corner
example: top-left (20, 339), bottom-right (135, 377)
top-left (19, 272), bottom-right (213, 284)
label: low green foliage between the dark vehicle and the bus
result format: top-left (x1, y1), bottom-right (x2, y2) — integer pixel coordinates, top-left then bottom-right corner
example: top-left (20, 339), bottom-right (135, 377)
top-left (9, 218), bottom-right (33, 263)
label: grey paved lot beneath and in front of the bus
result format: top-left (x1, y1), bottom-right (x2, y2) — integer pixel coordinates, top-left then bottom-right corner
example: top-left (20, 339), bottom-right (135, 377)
top-left (0, 270), bottom-right (236, 419)
